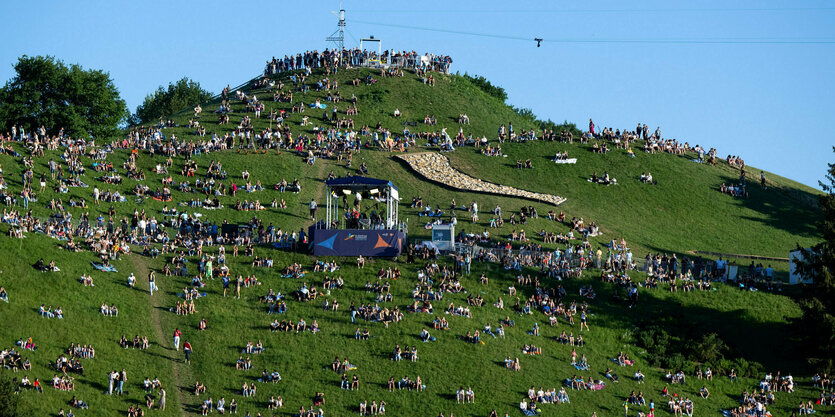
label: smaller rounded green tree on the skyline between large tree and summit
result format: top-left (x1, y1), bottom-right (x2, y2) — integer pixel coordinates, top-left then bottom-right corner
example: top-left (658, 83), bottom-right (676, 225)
top-left (131, 77), bottom-right (212, 124)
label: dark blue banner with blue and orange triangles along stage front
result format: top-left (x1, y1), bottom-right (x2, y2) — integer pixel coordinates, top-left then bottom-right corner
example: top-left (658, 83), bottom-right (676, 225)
top-left (310, 228), bottom-right (406, 257)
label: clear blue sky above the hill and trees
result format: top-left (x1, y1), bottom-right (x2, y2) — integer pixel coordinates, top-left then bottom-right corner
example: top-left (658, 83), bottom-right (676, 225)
top-left (0, 0), bottom-right (835, 187)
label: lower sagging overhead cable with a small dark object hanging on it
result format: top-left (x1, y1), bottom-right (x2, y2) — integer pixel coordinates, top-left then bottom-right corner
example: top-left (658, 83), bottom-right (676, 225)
top-left (351, 20), bottom-right (835, 45)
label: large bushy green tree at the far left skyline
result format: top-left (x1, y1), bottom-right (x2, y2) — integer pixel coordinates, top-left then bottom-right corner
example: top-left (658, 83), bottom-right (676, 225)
top-left (0, 55), bottom-right (129, 137)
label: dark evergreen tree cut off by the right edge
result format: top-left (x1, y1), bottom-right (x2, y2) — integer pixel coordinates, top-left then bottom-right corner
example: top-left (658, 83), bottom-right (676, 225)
top-left (799, 147), bottom-right (835, 372)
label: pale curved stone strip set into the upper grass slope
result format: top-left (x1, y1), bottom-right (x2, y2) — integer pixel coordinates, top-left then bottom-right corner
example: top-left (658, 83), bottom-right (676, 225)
top-left (399, 152), bottom-right (565, 205)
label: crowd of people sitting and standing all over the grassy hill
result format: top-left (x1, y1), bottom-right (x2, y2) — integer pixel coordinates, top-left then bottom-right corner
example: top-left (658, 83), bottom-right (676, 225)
top-left (0, 49), bottom-right (824, 417)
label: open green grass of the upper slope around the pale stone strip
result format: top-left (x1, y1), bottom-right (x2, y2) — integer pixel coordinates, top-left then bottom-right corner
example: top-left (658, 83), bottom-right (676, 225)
top-left (163, 69), bottom-right (820, 257)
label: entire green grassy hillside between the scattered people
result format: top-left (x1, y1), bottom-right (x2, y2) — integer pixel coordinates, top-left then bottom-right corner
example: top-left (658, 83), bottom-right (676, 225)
top-left (0, 65), bottom-right (833, 416)
